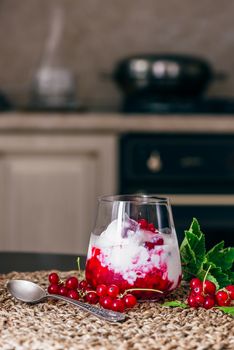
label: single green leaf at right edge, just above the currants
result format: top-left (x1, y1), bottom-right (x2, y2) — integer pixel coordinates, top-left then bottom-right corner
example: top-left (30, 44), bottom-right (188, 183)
top-left (206, 241), bottom-right (234, 271)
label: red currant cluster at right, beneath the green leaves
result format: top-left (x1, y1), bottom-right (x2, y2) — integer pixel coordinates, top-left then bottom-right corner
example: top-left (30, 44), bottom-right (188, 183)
top-left (187, 278), bottom-right (234, 309)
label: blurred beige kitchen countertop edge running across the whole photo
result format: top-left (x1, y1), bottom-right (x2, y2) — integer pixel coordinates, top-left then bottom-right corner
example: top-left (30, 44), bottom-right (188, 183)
top-left (0, 112), bottom-right (234, 134)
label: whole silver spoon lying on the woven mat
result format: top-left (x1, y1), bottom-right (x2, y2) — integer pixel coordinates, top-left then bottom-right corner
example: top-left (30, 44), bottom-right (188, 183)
top-left (7, 280), bottom-right (125, 322)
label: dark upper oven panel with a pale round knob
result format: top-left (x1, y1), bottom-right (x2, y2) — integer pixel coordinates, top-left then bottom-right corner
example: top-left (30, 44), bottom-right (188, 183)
top-left (121, 134), bottom-right (234, 184)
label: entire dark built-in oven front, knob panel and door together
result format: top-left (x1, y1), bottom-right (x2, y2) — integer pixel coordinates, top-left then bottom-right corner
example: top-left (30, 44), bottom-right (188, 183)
top-left (119, 134), bottom-right (234, 248)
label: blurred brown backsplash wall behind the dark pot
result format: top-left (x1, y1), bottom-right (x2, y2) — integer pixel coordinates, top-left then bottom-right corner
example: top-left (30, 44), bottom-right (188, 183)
top-left (0, 0), bottom-right (234, 110)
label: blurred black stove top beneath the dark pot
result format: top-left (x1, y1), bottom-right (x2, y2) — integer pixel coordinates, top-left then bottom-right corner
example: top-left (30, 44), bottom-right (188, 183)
top-left (122, 96), bottom-right (234, 114)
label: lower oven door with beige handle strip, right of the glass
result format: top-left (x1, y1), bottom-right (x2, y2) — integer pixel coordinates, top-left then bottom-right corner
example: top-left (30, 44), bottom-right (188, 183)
top-left (162, 194), bottom-right (234, 249)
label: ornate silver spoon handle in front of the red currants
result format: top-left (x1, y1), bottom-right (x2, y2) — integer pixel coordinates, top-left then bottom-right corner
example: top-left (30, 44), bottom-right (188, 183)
top-left (46, 294), bottom-right (125, 322)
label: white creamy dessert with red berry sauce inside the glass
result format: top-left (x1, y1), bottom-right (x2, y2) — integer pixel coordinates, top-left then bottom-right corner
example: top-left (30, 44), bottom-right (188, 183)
top-left (86, 214), bottom-right (181, 300)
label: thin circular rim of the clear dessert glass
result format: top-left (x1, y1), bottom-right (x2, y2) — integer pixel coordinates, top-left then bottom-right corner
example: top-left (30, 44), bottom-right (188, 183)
top-left (98, 194), bottom-right (170, 205)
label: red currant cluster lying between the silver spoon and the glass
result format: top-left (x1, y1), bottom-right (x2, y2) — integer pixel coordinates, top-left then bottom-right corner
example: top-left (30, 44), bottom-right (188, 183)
top-left (47, 272), bottom-right (137, 312)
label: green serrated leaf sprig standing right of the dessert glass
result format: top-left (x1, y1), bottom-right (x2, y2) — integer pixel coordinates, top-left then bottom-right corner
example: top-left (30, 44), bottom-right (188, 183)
top-left (180, 218), bottom-right (234, 289)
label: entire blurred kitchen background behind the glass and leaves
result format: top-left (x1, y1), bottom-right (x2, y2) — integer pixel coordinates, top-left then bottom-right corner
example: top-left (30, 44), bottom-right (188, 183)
top-left (0, 0), bottom-right (234, 254)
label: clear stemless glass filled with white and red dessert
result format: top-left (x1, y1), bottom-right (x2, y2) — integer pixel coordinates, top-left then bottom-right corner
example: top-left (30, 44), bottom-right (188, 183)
top-left (86, 195), bottom-right (181, 300)
